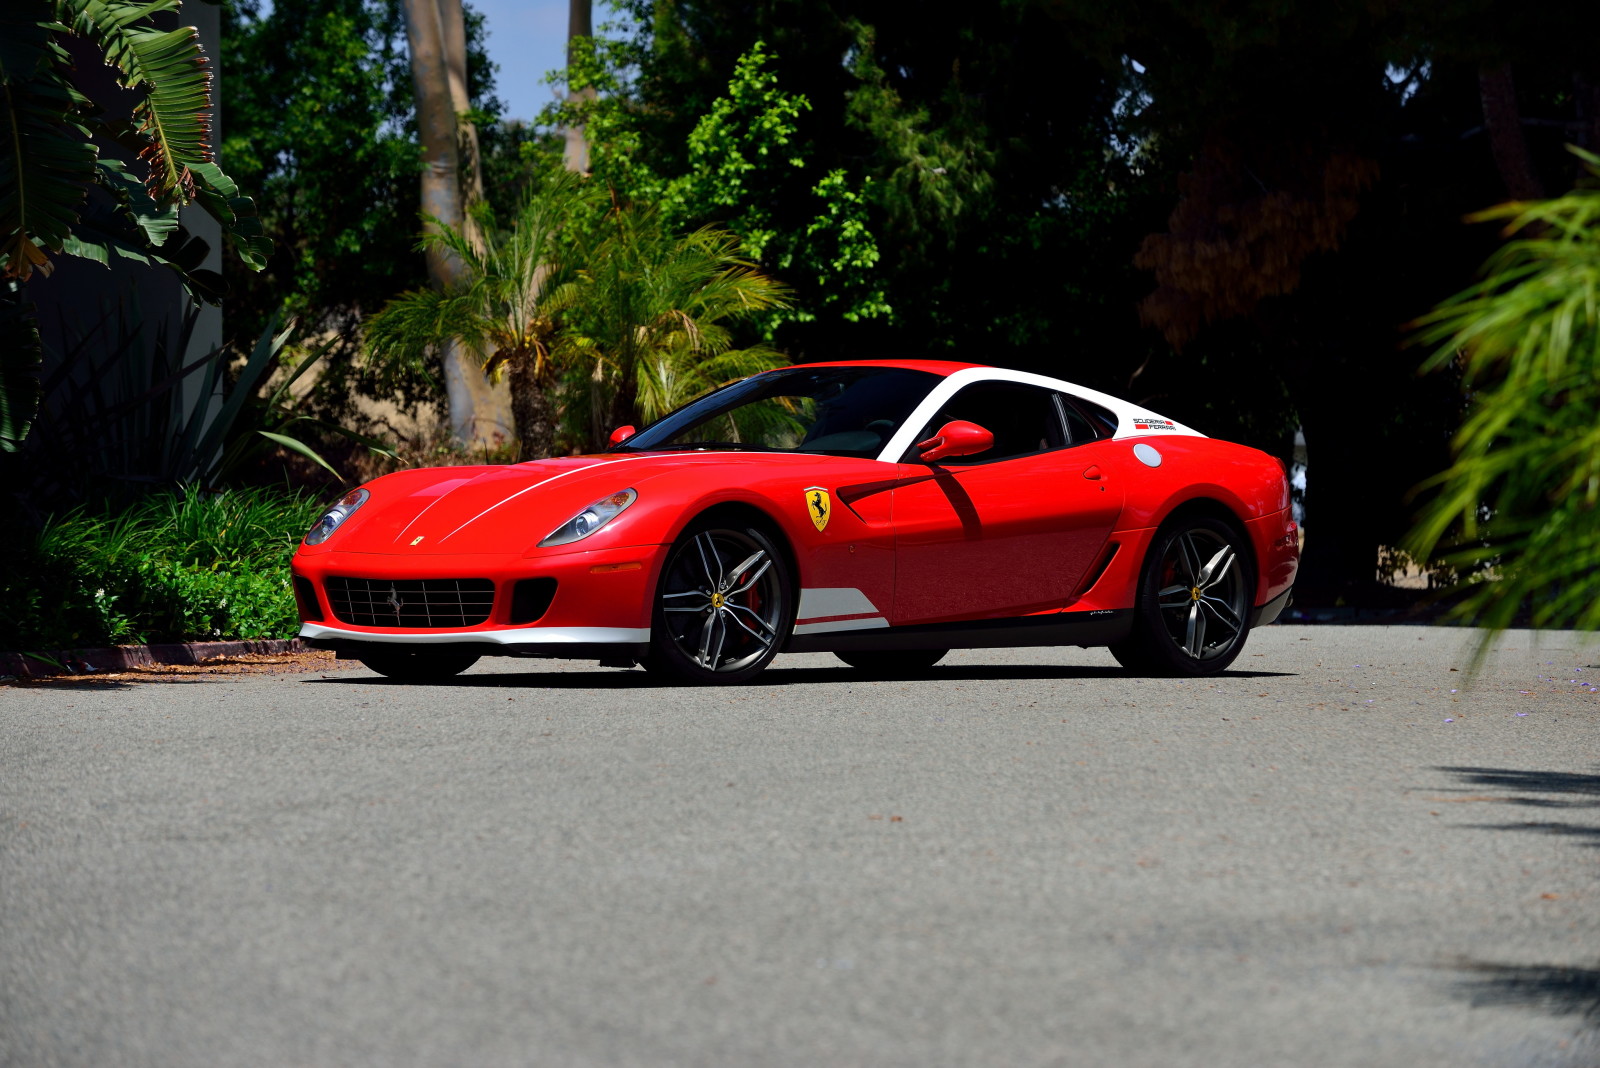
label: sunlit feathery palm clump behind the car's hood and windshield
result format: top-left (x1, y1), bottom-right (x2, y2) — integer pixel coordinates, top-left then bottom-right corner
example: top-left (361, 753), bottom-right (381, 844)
top-left (363, 173), bottom-right (787, 459)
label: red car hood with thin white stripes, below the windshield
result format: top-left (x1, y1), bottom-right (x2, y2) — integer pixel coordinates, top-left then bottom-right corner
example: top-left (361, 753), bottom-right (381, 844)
top-left (301, 452), bottom-right (889, 555)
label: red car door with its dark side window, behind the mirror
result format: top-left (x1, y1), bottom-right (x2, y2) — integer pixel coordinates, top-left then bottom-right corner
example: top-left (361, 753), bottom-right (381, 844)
top-left (891, 381), bottom-right (1123, 625)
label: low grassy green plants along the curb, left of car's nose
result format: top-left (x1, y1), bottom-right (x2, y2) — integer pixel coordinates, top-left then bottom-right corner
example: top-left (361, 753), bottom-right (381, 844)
top-left (0, 488), bottom-right (322, 651)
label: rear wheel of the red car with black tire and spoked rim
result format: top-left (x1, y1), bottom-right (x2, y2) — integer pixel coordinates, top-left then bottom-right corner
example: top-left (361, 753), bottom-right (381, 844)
top-left (1110, 515), bottom-right (1256, 676)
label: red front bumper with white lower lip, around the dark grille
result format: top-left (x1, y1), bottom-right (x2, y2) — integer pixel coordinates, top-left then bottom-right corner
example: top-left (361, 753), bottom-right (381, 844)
top-left (291, 545), bottom-right (664, 659)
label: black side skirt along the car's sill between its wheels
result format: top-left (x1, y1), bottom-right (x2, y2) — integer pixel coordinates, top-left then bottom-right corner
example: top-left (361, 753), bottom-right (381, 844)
top-left (784, 609), bottom-right (1133, 652)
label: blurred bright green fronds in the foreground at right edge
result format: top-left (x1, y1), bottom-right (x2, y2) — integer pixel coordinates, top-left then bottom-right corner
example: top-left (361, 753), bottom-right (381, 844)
top-left (1410, 152), bottom-right (1600, 630)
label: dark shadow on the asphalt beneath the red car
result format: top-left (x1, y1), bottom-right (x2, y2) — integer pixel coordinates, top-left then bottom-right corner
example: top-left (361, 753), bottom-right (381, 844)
top-left (306, 664), bottom-right (1293, 689)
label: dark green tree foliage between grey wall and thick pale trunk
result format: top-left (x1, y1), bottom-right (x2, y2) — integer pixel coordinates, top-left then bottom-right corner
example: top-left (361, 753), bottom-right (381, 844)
top-left (221, 0), bottom-right (422, 329)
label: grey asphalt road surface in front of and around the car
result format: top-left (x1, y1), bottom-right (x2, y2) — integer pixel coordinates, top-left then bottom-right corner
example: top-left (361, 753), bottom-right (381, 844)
top-left (0, 627), bottom-right (1600, 1068)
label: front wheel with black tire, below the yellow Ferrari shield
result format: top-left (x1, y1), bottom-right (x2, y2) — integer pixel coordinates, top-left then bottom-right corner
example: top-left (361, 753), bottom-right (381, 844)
top-left (643, 520), bottom-right (795, 686)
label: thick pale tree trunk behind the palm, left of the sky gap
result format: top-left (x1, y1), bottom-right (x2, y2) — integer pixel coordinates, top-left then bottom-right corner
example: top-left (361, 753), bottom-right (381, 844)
top-left (405, 0), bottom-right (512, 449)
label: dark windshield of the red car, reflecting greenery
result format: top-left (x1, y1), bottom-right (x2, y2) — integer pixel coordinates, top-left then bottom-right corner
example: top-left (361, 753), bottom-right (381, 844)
top-left (618, 368), bottom-right (939, 457)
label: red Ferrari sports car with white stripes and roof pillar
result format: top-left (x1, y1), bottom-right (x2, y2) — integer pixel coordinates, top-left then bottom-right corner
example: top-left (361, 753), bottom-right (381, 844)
top-left (293, 360), bottom-right (1299, 683)
